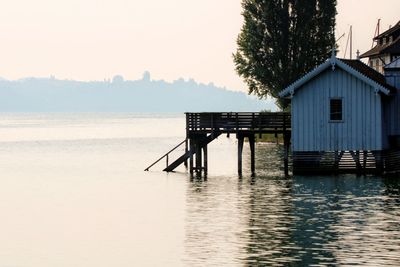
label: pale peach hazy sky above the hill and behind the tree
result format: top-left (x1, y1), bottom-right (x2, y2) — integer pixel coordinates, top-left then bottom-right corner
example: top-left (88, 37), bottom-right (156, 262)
top-left (0, 0), bottom-right (400, 90)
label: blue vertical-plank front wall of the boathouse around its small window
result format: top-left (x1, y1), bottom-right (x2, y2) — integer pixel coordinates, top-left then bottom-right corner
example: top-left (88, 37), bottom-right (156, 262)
top-left (292, 68), bottom-right (383, 151)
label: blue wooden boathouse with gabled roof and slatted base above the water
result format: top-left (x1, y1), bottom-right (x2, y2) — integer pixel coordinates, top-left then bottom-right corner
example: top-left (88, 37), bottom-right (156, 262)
top-left (280, 52), bottom-right (400, 173)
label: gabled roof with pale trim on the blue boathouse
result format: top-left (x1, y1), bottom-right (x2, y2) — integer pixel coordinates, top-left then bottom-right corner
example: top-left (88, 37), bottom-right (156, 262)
top-left (279, 56), bottom-right (396, 97)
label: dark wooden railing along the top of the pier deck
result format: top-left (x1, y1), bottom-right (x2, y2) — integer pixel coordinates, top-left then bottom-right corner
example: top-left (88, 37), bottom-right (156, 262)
top-left (186, 112), bottom-right (291, 135)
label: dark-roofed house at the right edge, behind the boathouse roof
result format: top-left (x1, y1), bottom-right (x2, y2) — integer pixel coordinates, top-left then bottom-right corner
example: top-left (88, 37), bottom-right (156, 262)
top-left (360, 21), bottom-right (400, 73)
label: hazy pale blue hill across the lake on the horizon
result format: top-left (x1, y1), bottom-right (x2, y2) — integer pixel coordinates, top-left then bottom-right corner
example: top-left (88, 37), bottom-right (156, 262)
top-left (0, 72), bottom-right (276, 112)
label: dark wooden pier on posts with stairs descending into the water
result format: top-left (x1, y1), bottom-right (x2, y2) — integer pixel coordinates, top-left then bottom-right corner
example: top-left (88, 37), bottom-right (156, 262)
top-left (145, 112), bottom-right (291, 176)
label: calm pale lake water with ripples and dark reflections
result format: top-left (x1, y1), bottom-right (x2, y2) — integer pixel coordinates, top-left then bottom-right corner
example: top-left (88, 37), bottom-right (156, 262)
top-left (0, 113), bottom-right (400, 267)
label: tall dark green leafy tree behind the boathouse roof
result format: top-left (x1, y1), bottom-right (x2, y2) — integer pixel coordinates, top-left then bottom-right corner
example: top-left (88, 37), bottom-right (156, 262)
top-left (233, 0), bottom-right (336, 109)
